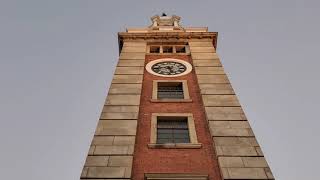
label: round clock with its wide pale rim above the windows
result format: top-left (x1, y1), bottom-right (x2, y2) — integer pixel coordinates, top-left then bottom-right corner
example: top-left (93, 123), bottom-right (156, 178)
top-left (146, 58), bottom-right (192, 77)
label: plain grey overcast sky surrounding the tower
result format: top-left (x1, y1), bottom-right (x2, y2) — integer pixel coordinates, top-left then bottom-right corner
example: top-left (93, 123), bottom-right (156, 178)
top-left (0, 0), bottom-right (320, 180)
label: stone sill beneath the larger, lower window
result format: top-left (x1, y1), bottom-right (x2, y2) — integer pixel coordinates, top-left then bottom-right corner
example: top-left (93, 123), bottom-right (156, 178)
top-left (148, 143), bottom-right (202, 149)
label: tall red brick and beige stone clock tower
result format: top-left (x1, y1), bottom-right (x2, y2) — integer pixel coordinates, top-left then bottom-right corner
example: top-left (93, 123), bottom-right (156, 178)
top-left (81, 15), bottom-right (274, 180)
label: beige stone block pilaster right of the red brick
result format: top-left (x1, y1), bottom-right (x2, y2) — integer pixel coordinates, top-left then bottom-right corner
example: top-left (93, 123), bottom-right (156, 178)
top-left (189, 39), bottom-right (274, 180)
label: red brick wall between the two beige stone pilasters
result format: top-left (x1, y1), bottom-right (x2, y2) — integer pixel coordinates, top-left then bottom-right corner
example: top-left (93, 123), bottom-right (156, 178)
top-left (132, 55), bottom-right (221, 180)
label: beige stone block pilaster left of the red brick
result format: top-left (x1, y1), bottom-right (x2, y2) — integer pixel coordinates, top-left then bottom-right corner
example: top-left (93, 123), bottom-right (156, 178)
top-left (81, 41), bottom-right (146, 180)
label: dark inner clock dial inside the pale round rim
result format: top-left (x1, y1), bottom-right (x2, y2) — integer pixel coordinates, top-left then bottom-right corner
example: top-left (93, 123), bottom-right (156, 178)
top-left (151, 61), bottom-right (187, 75)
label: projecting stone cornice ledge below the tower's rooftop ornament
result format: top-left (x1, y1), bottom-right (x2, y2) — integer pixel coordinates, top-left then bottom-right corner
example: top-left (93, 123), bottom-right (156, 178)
top-left (118, 32), bottom-right (218, 48)
